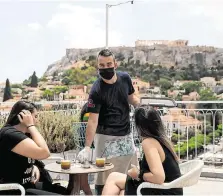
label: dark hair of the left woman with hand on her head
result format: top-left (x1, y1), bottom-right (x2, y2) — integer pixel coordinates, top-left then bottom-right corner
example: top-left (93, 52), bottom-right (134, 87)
top-left (5, 101), bottom-right (37, 126)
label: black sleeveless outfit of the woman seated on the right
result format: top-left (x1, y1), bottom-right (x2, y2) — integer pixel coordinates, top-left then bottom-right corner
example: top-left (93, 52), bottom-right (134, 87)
top-left (125, 142), bottom-right (183, 195)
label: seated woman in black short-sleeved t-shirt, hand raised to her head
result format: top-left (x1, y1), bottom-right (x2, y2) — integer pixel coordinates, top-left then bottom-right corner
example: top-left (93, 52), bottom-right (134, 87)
top-left (0, 101), bottom-right (65, 195)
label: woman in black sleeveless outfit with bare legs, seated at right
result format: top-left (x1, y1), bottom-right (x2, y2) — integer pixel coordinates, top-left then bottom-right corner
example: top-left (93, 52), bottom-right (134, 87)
top-left (102, 108), bottom-right (183, 195)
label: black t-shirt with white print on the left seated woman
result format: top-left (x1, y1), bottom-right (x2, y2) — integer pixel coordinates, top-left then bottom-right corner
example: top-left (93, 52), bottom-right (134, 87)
top-left (0, 126), bottom-right (35, 188)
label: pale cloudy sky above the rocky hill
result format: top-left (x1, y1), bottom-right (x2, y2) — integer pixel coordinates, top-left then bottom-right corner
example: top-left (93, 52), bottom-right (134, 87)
top-left (0, 0), bottom-right (223, 83)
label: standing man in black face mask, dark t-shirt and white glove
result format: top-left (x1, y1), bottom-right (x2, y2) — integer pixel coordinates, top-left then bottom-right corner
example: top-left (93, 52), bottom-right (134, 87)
top-left (78, 49), bottom-right (139, 195)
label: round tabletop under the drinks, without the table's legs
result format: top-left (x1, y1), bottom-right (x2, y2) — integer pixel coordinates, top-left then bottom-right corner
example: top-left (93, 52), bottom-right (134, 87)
top-left (45, 163), bottom-right (114, 174)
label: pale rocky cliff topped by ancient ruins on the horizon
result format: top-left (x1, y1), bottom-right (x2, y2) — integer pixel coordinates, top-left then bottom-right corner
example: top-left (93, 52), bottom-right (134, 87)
top-left (45, 40), bottom-right (223, 75)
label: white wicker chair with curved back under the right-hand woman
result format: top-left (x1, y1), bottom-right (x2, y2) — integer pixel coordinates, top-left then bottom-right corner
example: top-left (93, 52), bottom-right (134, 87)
top-left (137, 160), bottom-right (204, 196)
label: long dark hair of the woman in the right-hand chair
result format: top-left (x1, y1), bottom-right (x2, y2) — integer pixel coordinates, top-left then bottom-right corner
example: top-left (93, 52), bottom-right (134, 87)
top-left (135, 107), bottom-right (178, 161)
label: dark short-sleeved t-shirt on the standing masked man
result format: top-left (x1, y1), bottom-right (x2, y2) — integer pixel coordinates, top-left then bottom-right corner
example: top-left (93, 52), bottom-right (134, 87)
top-left (88, 72), bottom-right (135, 136)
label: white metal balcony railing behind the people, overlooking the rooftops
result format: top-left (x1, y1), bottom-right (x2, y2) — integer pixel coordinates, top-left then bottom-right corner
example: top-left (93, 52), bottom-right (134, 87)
top-left (0, 102), bottom-right (223, 166)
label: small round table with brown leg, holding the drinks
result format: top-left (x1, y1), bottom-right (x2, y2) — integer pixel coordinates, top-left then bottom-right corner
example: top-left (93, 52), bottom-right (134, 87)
top-left (45, 163), bottom-right (114, 195)
